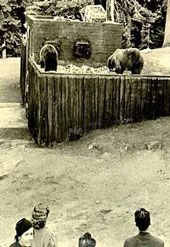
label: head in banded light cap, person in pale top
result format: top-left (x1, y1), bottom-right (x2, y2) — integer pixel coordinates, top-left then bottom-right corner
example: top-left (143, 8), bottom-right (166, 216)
top-left (32, 203), bottom-right (50, 228)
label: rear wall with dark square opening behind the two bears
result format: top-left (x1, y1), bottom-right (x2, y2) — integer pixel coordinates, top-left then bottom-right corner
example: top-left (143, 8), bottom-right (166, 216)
top-left (27, 15), bottom-right (123, 66)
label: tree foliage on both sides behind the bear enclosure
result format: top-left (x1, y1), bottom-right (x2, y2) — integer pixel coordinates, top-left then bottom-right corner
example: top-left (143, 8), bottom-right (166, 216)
top-left (0, 0), bottom-right (167, 56)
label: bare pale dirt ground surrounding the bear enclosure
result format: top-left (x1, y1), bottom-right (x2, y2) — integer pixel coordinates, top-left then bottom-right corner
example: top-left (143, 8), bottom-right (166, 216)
top-left (0, 48), bottom-right (170, 247)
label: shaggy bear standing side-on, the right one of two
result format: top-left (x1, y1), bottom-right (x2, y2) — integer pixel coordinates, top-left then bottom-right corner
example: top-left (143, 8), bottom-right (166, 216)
top-left (107, 48), bottom-right (144, 74)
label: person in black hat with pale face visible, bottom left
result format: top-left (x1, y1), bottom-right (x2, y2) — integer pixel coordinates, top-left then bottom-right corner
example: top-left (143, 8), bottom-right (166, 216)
top-left (10, 218), bottom-right (33, 247)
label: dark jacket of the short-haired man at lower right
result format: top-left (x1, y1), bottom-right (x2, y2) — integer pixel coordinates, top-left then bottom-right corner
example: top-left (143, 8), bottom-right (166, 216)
top-left (124, 232), bottom-right (164, 247)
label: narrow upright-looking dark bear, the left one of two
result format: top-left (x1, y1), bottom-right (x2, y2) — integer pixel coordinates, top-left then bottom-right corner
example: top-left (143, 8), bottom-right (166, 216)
top-left (40, 44), bottom-right (58, 71)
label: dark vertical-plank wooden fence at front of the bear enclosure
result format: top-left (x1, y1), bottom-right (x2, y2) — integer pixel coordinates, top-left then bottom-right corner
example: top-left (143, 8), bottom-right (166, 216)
top-left (28, 60), bottom-right (170, 146)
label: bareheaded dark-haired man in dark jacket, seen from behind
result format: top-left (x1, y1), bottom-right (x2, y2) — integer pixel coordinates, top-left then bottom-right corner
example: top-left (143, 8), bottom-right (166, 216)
top-left (124, 208), bottom-right (164, 247)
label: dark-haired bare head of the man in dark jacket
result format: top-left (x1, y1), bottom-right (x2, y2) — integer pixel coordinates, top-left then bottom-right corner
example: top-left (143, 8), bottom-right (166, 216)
top-left (135, 208), bottom-right (150, 231)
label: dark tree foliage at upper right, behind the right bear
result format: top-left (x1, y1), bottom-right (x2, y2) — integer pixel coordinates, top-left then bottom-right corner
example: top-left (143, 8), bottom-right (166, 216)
top-left (114, 0), bottom-right (167, 49)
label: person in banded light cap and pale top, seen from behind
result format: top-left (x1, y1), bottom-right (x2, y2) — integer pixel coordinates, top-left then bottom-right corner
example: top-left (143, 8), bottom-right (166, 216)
top-left (31, 203), bottom-right (57, 247)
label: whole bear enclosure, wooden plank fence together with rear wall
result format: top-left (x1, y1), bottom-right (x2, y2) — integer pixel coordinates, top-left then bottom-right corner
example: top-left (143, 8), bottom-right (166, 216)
top-left (20, 16), bottom-right (170, 146)
